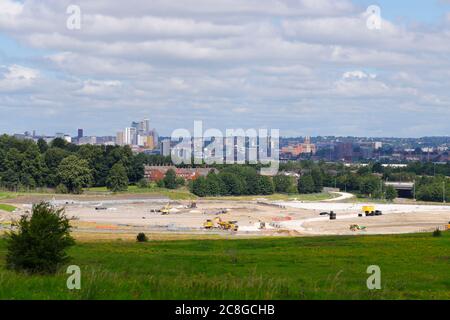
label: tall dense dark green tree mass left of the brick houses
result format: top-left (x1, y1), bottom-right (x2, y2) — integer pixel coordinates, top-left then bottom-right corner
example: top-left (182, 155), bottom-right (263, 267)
top-left (0, 135), bottom-right (171, 193)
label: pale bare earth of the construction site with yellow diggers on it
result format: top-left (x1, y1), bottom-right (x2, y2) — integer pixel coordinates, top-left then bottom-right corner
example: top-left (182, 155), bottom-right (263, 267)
top-left (0, 191), bottom-right (450, 240)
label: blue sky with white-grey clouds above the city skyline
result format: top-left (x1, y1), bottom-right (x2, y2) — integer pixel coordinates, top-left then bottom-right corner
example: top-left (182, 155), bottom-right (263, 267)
top-left (0, 0), bottom-right (450, 137)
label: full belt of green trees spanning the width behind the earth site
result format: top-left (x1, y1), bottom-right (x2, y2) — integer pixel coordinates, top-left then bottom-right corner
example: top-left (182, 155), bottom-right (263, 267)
top-left (0, 135), bottom-right (450, 201)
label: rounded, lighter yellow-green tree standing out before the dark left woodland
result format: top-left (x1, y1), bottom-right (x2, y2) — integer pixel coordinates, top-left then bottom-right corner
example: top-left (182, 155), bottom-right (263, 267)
top-left (58, 156), bottom-right (92, 194)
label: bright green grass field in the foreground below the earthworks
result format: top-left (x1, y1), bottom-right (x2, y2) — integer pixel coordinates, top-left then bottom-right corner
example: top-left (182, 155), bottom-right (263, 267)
top-left (0, 232), bottom-right (450, 299)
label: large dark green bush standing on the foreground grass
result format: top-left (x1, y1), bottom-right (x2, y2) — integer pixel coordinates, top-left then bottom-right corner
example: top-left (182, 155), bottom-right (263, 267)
top-left (6, 202), bottom-right (75, 273)
